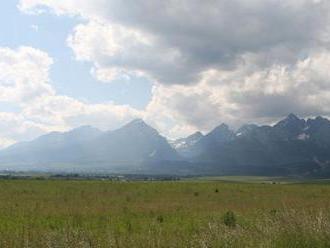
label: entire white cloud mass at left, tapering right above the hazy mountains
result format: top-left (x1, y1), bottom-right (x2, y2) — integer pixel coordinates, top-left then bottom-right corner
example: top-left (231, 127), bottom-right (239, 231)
top-left (0, 47), bottom-right (142, 147)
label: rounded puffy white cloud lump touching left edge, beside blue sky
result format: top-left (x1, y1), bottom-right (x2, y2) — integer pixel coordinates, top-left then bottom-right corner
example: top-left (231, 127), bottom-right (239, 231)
top-left (0, 47), bottom-right (54, 104)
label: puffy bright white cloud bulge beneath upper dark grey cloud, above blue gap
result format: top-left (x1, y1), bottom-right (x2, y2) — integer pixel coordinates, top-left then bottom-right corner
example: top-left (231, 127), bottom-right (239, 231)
top-left (68, 21), bottom-right (187, 83)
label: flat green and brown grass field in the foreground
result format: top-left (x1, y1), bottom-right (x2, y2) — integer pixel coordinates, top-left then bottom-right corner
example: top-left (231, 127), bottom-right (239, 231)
top-left (0, 180), bottom-right (330, 247)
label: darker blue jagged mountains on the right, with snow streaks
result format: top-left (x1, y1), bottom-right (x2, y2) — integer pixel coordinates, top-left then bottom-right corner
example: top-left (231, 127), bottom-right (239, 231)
top-left (179, 114), bottom-right (330, 173)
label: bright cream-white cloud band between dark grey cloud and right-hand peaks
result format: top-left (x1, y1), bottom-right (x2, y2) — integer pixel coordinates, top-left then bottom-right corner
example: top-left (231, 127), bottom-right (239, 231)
top-left (147, 51), bottom-right (330, 135)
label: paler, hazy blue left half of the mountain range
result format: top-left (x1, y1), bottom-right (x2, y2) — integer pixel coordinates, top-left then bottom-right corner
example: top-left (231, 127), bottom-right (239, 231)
top-left (0, 120), bottom-right (179, 169)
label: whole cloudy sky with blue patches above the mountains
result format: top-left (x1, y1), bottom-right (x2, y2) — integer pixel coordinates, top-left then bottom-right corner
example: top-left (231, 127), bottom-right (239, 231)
top-left (0, 0), bottom-right (330, 148)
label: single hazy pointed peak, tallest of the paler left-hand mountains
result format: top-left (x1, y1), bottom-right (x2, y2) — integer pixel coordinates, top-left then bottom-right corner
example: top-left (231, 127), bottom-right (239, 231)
top-left (86, 119), bottom-right (179, 164)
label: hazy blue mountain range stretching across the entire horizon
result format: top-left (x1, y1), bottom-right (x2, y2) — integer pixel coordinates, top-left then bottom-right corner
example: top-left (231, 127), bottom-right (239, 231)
top-left (0, 114), bottom-right (330, 176)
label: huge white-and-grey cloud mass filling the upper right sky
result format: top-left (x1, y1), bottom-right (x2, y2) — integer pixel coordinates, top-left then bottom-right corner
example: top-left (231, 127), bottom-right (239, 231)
top-left (19, 0), bottom-right (330, 136)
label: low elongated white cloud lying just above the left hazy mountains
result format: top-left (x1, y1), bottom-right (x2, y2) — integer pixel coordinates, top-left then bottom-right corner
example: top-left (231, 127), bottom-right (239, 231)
top-left (22, 95), bottom-right (142, 130)
